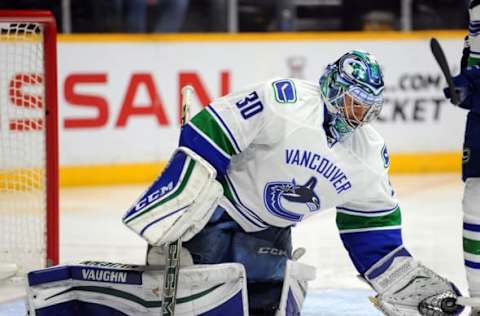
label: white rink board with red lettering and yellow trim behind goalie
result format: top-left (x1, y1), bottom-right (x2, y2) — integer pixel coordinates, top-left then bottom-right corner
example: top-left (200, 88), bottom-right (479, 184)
top-left (0, 32), bottom-right (465, 185)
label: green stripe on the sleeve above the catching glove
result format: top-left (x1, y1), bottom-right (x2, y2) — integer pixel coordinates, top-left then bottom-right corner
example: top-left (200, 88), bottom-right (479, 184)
top-left (336, 207), bottom-right (402, 231)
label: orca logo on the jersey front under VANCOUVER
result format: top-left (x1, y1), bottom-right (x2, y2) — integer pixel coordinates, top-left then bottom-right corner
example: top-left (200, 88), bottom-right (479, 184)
top-left (263, 177), bottom-right (320, 222)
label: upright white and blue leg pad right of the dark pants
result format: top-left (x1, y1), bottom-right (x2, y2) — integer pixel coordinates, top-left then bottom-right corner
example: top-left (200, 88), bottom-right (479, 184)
top-left (275, 260), bottom-right (315, 316)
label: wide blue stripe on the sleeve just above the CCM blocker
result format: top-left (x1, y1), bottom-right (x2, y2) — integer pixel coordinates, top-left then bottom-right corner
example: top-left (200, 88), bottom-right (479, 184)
top-left (180, 124), bottom-right (230, 175)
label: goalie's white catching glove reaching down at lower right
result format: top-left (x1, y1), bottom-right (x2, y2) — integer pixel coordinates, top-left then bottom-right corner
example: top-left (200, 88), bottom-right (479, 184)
top-left (365, 247), bottom-right (463, 316)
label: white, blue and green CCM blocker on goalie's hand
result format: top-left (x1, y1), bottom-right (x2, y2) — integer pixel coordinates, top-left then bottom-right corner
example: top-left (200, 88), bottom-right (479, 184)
top-left (122, 147), bottom-right (223, 246)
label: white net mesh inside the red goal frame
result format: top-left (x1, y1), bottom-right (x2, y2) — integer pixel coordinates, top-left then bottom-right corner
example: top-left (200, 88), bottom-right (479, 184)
top-left (0, 22), bottom-right (47, 273)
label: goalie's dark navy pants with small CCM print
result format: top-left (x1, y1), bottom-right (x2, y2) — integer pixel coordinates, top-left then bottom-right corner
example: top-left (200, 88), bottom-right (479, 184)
top-left (183, 207), bottom-right (292, 315)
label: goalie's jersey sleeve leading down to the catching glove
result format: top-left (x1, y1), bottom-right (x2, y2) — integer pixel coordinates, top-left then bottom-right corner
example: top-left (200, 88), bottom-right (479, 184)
top-left (336, 131), bottom-right (403, 275)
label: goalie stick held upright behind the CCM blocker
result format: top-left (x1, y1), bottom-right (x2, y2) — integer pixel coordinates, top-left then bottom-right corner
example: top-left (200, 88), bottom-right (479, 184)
top-left (162, 85), bottom-right (194, 316)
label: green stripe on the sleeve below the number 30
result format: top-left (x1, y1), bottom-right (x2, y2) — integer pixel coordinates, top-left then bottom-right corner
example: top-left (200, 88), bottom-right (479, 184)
top-left (191, 109), bottom-right (236, 156)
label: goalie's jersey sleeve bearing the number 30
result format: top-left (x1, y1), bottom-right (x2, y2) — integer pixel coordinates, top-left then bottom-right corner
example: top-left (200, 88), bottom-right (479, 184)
top-left (180, 83), bottom-right (271, 175)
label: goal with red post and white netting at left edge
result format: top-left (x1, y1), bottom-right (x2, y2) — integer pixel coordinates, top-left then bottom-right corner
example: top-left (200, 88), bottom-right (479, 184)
top-left (0, 10), bottom-right (58, 276)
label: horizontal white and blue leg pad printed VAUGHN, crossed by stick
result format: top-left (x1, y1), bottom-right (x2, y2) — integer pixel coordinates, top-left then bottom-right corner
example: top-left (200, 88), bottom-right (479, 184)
top-left (27, 262), bottom-right (248, 316)
